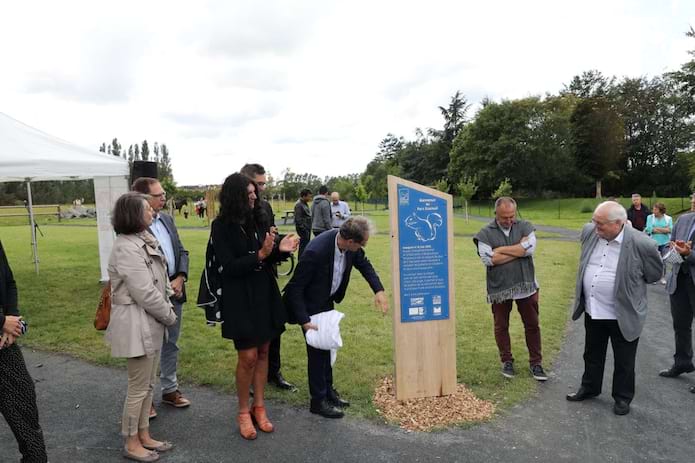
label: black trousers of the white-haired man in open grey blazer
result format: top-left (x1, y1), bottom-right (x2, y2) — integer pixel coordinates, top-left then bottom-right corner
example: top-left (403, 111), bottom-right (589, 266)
top-left (582, 318), bottom-right (639, 403)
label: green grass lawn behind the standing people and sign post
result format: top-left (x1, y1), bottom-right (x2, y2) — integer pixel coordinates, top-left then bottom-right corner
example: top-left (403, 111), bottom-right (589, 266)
top-left (0, 213), bottom-right (578, 424)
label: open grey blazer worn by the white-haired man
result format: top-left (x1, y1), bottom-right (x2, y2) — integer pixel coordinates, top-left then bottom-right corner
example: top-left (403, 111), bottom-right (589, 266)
top-left (572, 223), bottom-right (664, 341)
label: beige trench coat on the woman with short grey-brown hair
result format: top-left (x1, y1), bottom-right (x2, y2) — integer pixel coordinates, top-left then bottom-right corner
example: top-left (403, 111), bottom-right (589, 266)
top-left (105, 235), bottom-right (176, 358)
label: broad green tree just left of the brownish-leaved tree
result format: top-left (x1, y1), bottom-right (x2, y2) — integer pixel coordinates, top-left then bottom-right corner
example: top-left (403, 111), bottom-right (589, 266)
top-left (449, 95), bottom-right (581, 197)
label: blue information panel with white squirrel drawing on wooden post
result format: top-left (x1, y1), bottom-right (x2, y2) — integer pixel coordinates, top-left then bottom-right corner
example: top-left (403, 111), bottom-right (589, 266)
top-left (397, 184), bottom-right (449, 322)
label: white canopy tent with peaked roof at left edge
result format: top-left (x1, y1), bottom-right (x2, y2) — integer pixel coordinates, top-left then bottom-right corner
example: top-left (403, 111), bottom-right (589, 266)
top-left (0, 112), bottom-right (128, 281)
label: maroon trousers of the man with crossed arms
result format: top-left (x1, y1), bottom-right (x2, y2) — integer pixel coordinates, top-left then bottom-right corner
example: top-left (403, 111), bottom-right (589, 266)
top-left (492, 291), bottom-right (542, 366)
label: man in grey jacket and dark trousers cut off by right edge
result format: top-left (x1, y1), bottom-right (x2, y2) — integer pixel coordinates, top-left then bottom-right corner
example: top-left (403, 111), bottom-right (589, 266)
top-left (659, 194), bottom-right (695, 393)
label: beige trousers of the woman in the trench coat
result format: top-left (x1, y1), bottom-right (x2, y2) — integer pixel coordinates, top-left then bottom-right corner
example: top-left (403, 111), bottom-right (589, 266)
top-left (121, 351), bottom-right (160, 437)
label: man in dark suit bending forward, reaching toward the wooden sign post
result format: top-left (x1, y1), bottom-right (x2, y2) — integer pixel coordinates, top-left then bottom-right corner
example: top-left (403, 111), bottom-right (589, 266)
top-left (284, 216), bottom-right (388, 418)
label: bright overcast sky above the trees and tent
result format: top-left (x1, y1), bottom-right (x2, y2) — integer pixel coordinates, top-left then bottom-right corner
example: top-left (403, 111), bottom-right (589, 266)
top-left (0, 0), bottom-right (695, 185)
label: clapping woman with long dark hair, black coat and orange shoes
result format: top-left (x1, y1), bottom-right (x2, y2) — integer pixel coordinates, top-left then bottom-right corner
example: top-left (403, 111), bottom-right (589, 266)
top-left (208, 173), bottom-right (299, 439)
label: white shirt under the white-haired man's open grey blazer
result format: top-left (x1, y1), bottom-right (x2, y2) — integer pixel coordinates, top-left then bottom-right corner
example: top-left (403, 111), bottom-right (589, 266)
top-left (582, 228), bottom-right (625, 320)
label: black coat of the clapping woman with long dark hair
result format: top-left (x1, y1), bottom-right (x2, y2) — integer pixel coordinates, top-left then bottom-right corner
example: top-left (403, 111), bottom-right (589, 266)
top-left (210, 219), bottom-right (286, 341)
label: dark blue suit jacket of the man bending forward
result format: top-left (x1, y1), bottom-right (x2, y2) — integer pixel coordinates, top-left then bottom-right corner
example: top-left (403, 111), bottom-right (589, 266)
top-left (284, 230), bottom-right (384, 325)
